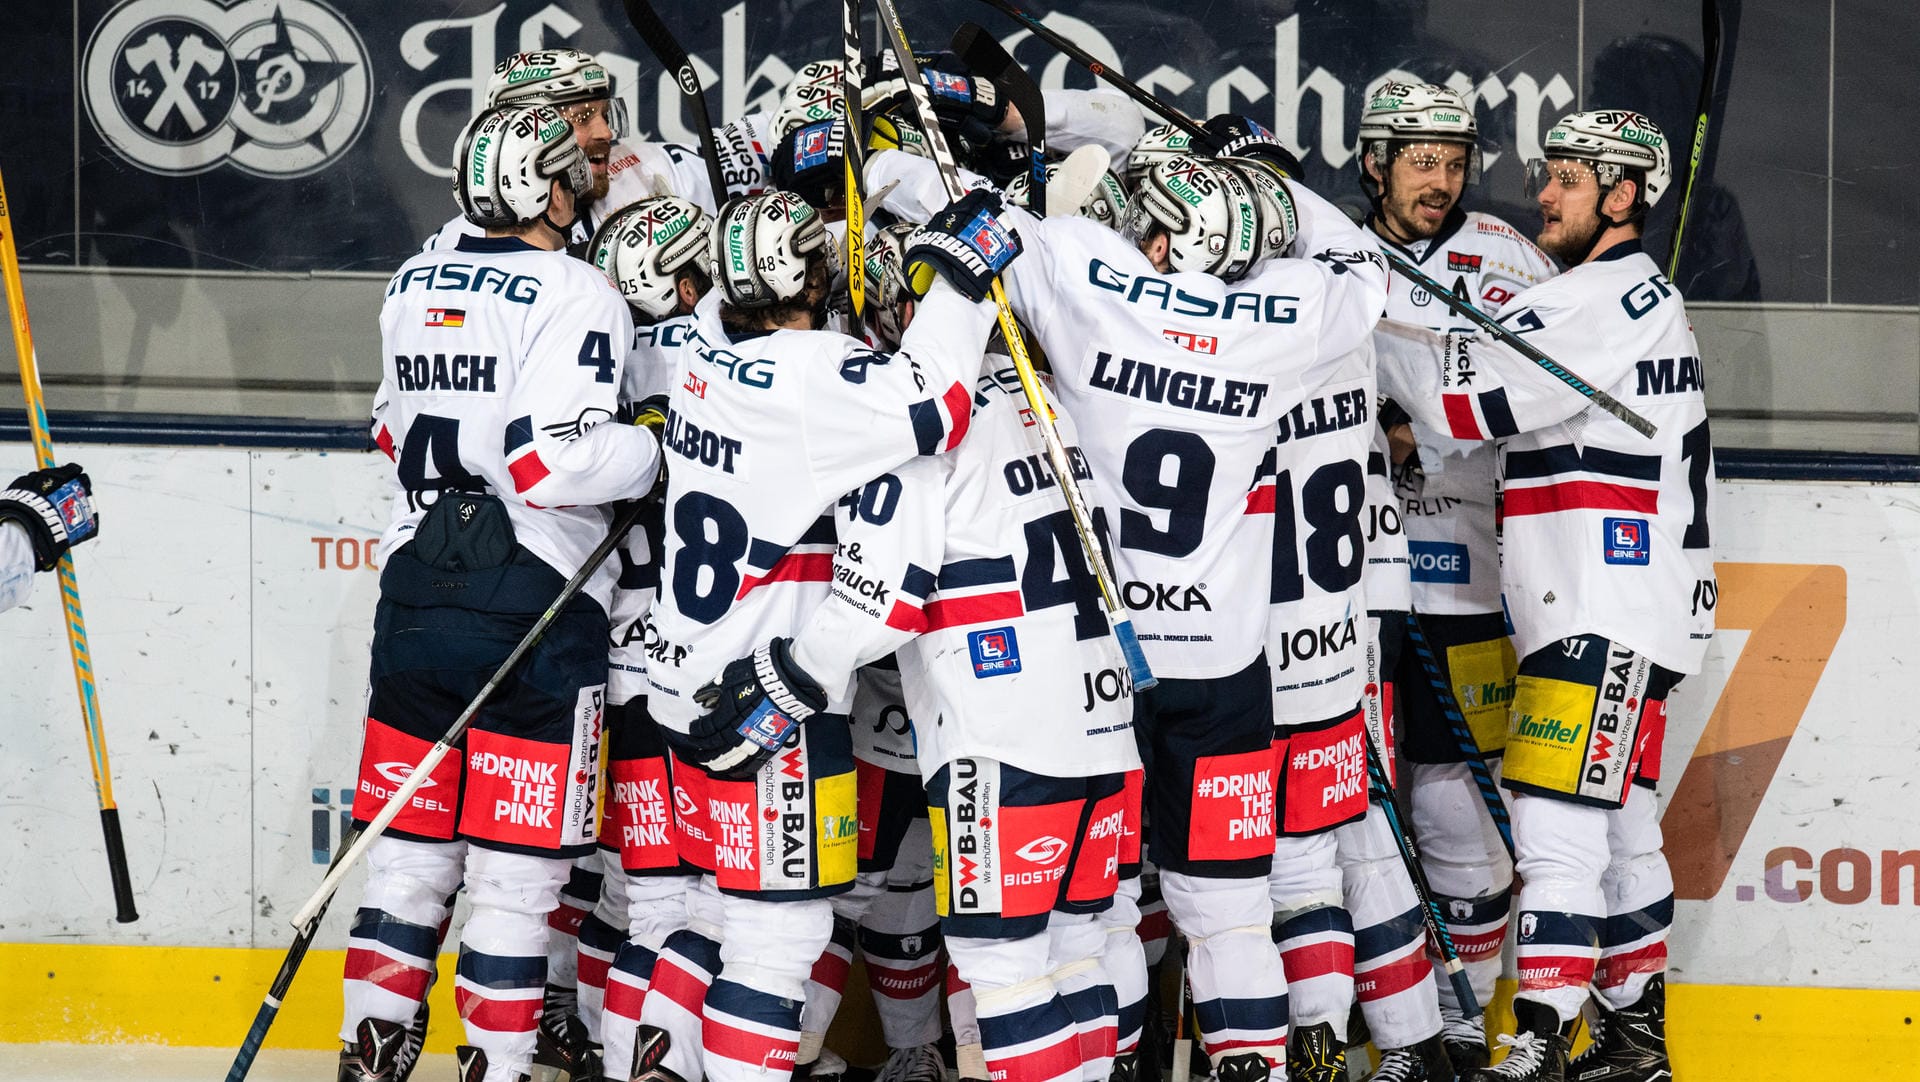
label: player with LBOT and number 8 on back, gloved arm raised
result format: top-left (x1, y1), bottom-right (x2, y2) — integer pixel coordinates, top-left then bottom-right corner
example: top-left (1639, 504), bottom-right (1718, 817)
top-left (643, 192), bottom-right (1016, 1082)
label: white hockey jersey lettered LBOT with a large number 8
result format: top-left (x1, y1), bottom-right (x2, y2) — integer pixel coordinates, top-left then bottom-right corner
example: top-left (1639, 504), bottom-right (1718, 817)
top-left (647, 282), bottom-right (993, 731)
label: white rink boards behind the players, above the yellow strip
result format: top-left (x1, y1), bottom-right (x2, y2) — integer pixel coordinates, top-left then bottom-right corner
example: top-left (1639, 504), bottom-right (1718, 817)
top-left (0, 443), bottom-right (1920, 988)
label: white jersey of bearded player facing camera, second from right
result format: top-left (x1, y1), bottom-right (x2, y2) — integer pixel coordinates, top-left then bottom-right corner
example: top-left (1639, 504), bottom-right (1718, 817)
top-left (1369, 211), bottom-right (1559, 616)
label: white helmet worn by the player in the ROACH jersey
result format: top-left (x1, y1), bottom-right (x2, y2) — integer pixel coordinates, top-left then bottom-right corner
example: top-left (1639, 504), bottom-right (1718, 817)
top-left (453, 106), bottom-right (593, 232)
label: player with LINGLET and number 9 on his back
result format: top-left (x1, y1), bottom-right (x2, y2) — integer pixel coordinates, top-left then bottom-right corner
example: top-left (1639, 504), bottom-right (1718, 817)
top-left (868, 145), bottom-right (1384, 1080)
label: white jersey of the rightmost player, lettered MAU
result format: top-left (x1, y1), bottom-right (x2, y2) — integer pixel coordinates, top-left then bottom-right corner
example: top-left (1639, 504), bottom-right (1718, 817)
top-left (1375, 242), bottom-right (1718, 673)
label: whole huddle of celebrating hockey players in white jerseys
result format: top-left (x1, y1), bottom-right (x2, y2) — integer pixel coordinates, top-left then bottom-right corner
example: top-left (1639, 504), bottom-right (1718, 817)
top-left (340, 27), bottom-right (1716, 1082)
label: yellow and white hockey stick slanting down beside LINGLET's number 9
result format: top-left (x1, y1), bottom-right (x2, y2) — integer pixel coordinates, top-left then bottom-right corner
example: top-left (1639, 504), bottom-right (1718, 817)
top-left (876, 0), bottom-right (1158, 691)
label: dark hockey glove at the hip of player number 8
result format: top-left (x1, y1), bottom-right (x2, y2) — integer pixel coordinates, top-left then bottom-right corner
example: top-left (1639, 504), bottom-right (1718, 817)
top-left (678, 639), bottom-right (828, 781)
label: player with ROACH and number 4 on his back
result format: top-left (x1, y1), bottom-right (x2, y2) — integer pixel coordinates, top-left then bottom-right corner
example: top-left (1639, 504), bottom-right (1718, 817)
top-left (340, 107), bottom-right (659, 1082)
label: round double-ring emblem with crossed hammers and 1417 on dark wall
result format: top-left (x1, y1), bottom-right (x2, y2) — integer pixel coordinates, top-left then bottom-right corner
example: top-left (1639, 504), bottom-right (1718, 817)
top-left (83, 0), bottom-right (372, 176)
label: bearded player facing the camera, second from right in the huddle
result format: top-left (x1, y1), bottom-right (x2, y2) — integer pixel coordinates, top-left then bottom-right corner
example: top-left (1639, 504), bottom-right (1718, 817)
top-left (1359, 81), bottom-right (1555, 1072)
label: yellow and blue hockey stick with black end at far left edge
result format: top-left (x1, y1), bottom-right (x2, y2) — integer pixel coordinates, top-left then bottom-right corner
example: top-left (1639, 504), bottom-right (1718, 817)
top-left (0, 166), bottom-right (140, 925)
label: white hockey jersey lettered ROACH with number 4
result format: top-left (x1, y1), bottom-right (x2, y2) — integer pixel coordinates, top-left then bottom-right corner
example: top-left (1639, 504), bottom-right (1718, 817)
top-left (372, 238), bottom-right (660, 606)
